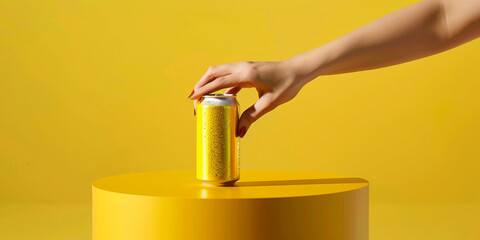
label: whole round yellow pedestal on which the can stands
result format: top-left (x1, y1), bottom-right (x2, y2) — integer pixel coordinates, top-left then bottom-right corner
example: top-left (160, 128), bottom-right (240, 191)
top-left (93, 170), bottom-right (368, 240)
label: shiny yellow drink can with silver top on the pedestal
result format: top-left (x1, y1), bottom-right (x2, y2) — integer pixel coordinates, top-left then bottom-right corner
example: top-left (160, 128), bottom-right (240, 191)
top-left (197, 94), bottom-right (240, 185)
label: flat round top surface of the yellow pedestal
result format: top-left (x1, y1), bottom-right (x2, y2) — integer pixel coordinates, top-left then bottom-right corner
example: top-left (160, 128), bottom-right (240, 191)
top-left (93, 170), bottom-right (368, 199)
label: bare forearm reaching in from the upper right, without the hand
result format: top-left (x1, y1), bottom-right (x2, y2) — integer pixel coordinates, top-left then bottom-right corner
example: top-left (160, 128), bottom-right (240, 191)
top-left (286, 0), bottom-right (480, 82)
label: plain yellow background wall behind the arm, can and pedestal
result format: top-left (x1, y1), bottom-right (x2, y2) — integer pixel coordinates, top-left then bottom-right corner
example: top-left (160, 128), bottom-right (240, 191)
top-left (0, 0), bottom-right (480, 239)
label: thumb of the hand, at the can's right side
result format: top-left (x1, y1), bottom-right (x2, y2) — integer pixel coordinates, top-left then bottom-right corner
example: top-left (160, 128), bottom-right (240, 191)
top-left (237, 94), bottom-right (275, 138)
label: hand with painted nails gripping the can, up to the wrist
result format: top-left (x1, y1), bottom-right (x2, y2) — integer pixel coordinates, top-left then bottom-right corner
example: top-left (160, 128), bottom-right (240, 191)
top-left (189, 61), bottom-right (305, 138)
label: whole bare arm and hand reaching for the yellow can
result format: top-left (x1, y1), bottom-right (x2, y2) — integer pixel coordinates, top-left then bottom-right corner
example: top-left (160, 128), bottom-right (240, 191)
top-left (189, 0), bottom-right (480, 137)
